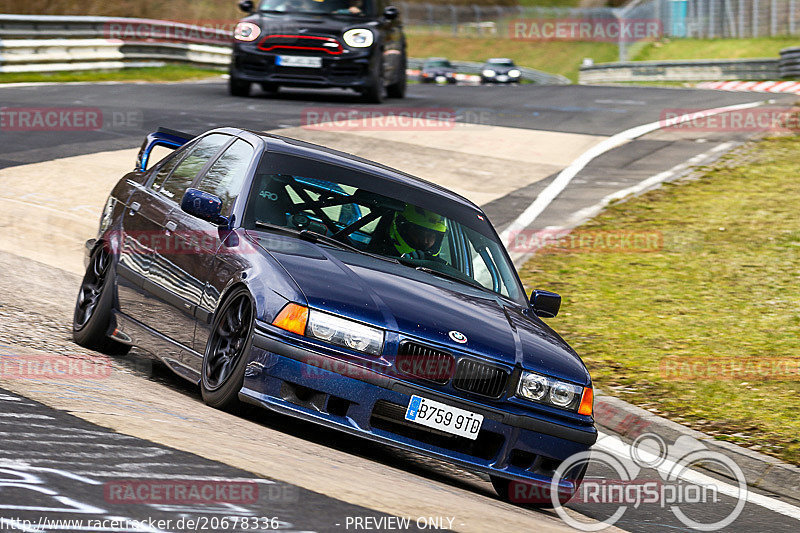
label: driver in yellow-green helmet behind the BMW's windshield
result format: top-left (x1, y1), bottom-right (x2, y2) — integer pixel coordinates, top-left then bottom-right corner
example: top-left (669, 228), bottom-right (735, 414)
top-left (389, 204), bottom-right (447, 259)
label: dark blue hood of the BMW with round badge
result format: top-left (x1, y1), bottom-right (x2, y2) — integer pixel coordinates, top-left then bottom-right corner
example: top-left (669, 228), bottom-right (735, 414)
top-left (257, 235), bottom-right (591, 385)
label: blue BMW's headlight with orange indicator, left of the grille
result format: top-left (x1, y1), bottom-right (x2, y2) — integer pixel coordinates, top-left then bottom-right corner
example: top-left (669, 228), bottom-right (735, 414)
top-left (272, 303), bottom-right (384, 355)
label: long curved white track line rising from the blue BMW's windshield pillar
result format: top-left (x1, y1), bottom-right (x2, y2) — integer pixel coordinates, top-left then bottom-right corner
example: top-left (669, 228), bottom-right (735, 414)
top-left (500, 101), bottom-right (766, 249)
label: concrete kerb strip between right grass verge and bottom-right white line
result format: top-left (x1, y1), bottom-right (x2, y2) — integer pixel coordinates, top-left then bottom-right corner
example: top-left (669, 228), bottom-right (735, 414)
top-left (594, 390), bottom-right (800, 502)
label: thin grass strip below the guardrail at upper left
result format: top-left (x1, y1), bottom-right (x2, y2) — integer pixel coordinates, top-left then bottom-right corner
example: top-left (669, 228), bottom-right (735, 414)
top-left (0, 65), bottom-right (222, 83)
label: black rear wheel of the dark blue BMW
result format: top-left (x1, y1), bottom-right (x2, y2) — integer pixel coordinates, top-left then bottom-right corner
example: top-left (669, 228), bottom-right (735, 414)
top-left (72, 246), bottom-right (130, 355)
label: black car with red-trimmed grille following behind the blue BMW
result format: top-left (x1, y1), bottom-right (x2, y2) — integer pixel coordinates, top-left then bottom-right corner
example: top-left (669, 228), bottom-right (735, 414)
top-left (229, 0), bottom-right (407, 103)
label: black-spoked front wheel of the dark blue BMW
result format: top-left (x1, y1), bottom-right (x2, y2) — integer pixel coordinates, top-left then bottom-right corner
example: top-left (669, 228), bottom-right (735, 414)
top-left (201, 288), bottom-right (255, 409)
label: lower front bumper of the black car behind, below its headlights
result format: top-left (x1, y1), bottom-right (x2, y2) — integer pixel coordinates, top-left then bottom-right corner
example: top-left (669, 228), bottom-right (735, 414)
top-left (230, 45), bottom-right (372, 89)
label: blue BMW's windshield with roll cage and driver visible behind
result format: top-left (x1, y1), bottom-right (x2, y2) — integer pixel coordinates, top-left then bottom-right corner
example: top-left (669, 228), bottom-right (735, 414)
top-left (244, 170), bottom-right (524, 302)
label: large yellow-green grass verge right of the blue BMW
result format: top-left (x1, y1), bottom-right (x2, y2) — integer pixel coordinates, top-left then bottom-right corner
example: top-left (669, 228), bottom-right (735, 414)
top-left (521, 136), bottom-right (800, 464)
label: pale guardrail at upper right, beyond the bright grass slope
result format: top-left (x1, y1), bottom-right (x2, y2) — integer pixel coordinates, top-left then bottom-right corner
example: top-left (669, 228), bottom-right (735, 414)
top-left (578, 58), bottom-right (780, 84)
